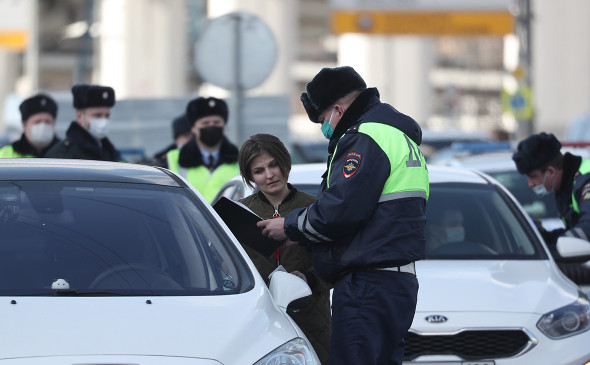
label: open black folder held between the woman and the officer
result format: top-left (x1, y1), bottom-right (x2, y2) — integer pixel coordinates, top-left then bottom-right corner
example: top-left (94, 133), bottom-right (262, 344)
top-left (213, 196), bottom-right (283, 256)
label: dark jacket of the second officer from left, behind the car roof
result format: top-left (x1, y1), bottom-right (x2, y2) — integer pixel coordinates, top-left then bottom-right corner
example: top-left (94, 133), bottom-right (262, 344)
top-left (45, 121), bottom-right (123, 161)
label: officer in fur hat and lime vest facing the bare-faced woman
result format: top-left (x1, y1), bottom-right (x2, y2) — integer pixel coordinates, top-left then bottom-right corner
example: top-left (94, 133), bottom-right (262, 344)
top-left (258, 66), bottom-right (429, 365)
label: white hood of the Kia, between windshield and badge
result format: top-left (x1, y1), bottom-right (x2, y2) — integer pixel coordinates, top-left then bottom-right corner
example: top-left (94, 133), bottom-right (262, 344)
top-left (416, 260), bottom-right (578, 314)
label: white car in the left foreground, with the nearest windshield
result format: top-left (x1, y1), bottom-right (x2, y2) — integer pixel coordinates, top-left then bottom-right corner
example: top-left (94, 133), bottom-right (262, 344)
top-left (0, 159), bottom-right (319, 365)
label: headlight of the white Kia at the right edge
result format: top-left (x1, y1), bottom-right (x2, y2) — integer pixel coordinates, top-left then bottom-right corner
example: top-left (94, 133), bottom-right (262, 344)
top-left (537, 296), bottom-right (590, 339)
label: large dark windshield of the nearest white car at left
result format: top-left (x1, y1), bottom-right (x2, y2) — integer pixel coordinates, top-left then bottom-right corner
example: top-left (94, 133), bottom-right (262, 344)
top-left (0, 181), bottom-right (252, 295)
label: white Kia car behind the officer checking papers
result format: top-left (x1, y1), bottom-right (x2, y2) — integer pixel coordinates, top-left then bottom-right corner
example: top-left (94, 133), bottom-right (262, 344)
top-left (215, 165), bottom-right (590, 365)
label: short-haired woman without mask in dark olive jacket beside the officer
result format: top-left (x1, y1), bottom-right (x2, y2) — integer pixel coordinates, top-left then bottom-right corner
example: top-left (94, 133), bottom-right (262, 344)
top-left (238, 134), bottom-right (332, 364)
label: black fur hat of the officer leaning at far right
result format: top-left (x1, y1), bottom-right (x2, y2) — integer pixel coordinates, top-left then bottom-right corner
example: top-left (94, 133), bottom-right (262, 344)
top-left (512, 132), bottom-right (561, 175)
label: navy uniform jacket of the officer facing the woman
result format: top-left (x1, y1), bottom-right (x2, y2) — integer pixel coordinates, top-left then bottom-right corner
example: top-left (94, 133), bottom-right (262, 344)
top-left (285, 88), bottom-right (428, 282)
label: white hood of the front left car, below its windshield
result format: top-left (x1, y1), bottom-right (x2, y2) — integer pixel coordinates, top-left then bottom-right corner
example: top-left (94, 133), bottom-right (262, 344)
top-left (0, 289), bottom-right (300, 364)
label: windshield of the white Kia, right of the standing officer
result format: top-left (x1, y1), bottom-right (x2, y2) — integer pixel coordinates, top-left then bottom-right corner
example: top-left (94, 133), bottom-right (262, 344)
top-left (426, 183), bottom-right (545, 260)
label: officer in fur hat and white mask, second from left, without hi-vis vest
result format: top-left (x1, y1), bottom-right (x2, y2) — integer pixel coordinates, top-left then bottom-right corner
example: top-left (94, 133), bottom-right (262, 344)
top-left (46, 85), bottom-right (123, 161)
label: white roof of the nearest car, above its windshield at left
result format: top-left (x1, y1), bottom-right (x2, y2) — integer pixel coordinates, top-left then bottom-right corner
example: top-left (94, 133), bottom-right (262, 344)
top-left (0, 158), bottom-right (180, 186)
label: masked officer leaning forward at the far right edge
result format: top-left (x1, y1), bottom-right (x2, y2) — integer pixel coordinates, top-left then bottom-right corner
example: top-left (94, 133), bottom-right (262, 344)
top-left (512, 132), bottom-right (590, 285)
